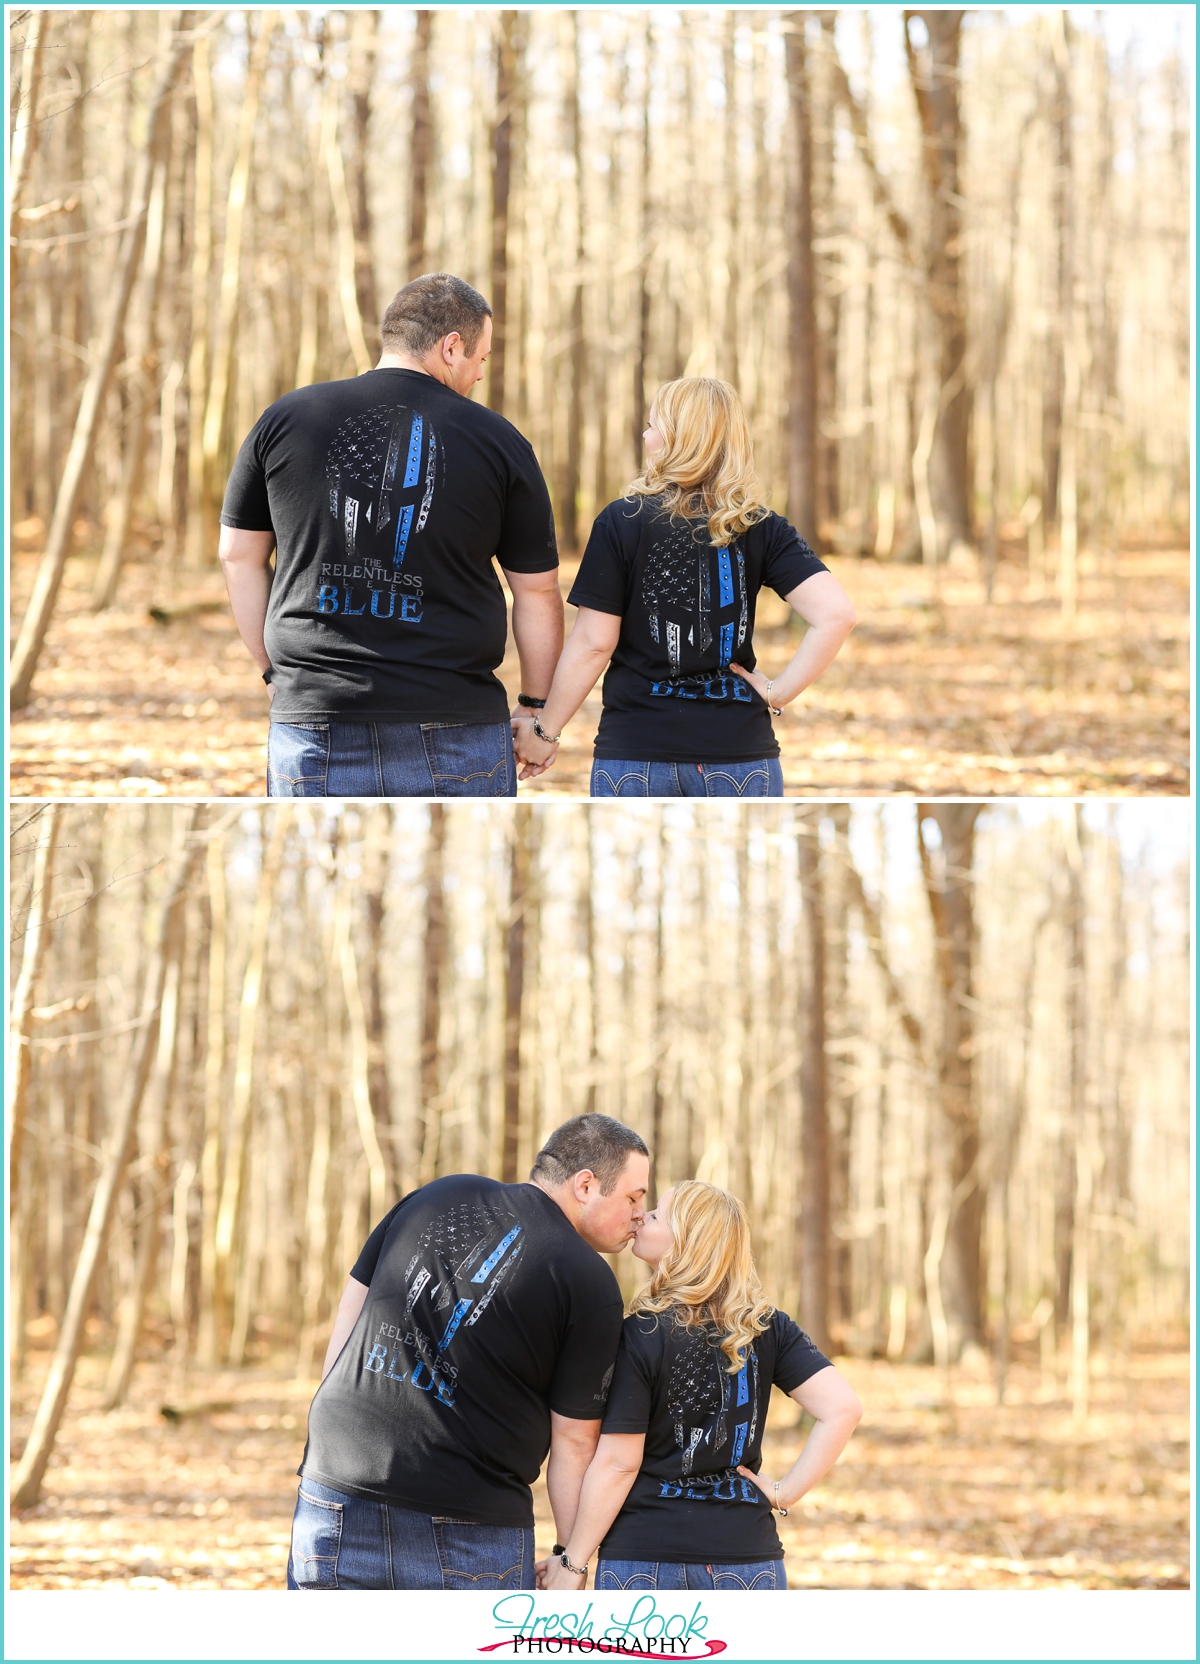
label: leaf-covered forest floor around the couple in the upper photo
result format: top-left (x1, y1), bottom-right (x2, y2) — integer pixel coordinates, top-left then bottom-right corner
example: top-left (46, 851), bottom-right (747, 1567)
top-left (10, 521), bottom-right (1190, 797)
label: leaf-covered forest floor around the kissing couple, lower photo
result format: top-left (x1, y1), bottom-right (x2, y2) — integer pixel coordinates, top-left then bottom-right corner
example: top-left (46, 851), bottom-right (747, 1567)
top-left (12, 1343), bottom-right (1190, 1589)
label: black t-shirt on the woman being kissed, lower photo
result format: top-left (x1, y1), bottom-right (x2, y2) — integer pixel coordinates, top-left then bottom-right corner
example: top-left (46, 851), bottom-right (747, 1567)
top-left (601, 1311), bottom-right (829, 1566)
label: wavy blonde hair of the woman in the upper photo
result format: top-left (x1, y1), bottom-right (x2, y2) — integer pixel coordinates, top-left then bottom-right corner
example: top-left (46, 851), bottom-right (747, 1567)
top-left (626, 376), bottom-right (769, 549)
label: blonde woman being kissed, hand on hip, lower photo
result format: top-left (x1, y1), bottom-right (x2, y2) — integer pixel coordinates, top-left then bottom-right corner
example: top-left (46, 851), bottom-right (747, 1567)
top-left (539, 1178), bottom-right (862, 1589)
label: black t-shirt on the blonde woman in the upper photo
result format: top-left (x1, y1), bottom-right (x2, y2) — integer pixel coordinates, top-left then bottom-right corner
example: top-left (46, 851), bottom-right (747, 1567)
top-left (568, 498), bottom-right (827, 762)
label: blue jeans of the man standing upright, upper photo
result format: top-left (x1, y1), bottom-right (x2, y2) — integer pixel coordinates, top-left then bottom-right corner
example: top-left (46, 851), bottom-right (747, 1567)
top-left (266, 722), bottom-right (516, 797)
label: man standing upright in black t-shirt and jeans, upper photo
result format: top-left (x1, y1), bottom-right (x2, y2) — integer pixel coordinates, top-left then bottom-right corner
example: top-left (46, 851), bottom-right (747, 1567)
top-left (220, 271), bottom-right (563, 797)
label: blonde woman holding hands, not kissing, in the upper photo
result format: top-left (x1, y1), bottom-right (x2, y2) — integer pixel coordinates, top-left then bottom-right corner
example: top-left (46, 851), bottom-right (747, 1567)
top-left (514, 376), bottom-right (854, 797)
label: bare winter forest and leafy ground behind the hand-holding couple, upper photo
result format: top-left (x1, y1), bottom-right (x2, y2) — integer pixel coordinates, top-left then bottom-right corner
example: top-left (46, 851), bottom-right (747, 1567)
top-left (7, 7), bottom-right (1193, 797)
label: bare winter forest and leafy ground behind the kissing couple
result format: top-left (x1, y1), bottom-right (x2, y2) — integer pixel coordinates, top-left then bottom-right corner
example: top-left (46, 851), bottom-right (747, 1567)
top-left (8, 802), bottom-right (1192, 1587)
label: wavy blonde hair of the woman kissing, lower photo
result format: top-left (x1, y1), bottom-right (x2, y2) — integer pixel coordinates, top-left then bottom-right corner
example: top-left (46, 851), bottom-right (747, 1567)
top-left (627, 1178), bottom-right (776, 1374)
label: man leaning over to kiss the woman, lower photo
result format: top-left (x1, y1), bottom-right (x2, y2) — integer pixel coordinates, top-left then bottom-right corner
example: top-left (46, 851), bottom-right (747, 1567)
top-left (288, 1115), bottom-right (649, 1589)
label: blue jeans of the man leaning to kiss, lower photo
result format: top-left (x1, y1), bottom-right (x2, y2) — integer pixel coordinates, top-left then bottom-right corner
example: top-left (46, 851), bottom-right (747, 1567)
top-left (288, 1479), bottom-right (534, 1591)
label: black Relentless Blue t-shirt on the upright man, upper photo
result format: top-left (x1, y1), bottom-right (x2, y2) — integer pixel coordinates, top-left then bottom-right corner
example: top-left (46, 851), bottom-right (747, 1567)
top-left (221, 369), bottom-right (558, 722)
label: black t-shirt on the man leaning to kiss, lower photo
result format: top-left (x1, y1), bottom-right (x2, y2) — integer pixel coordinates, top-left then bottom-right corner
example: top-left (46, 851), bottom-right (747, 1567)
top-left (300, 1173), bottom-right (622, 1526)
